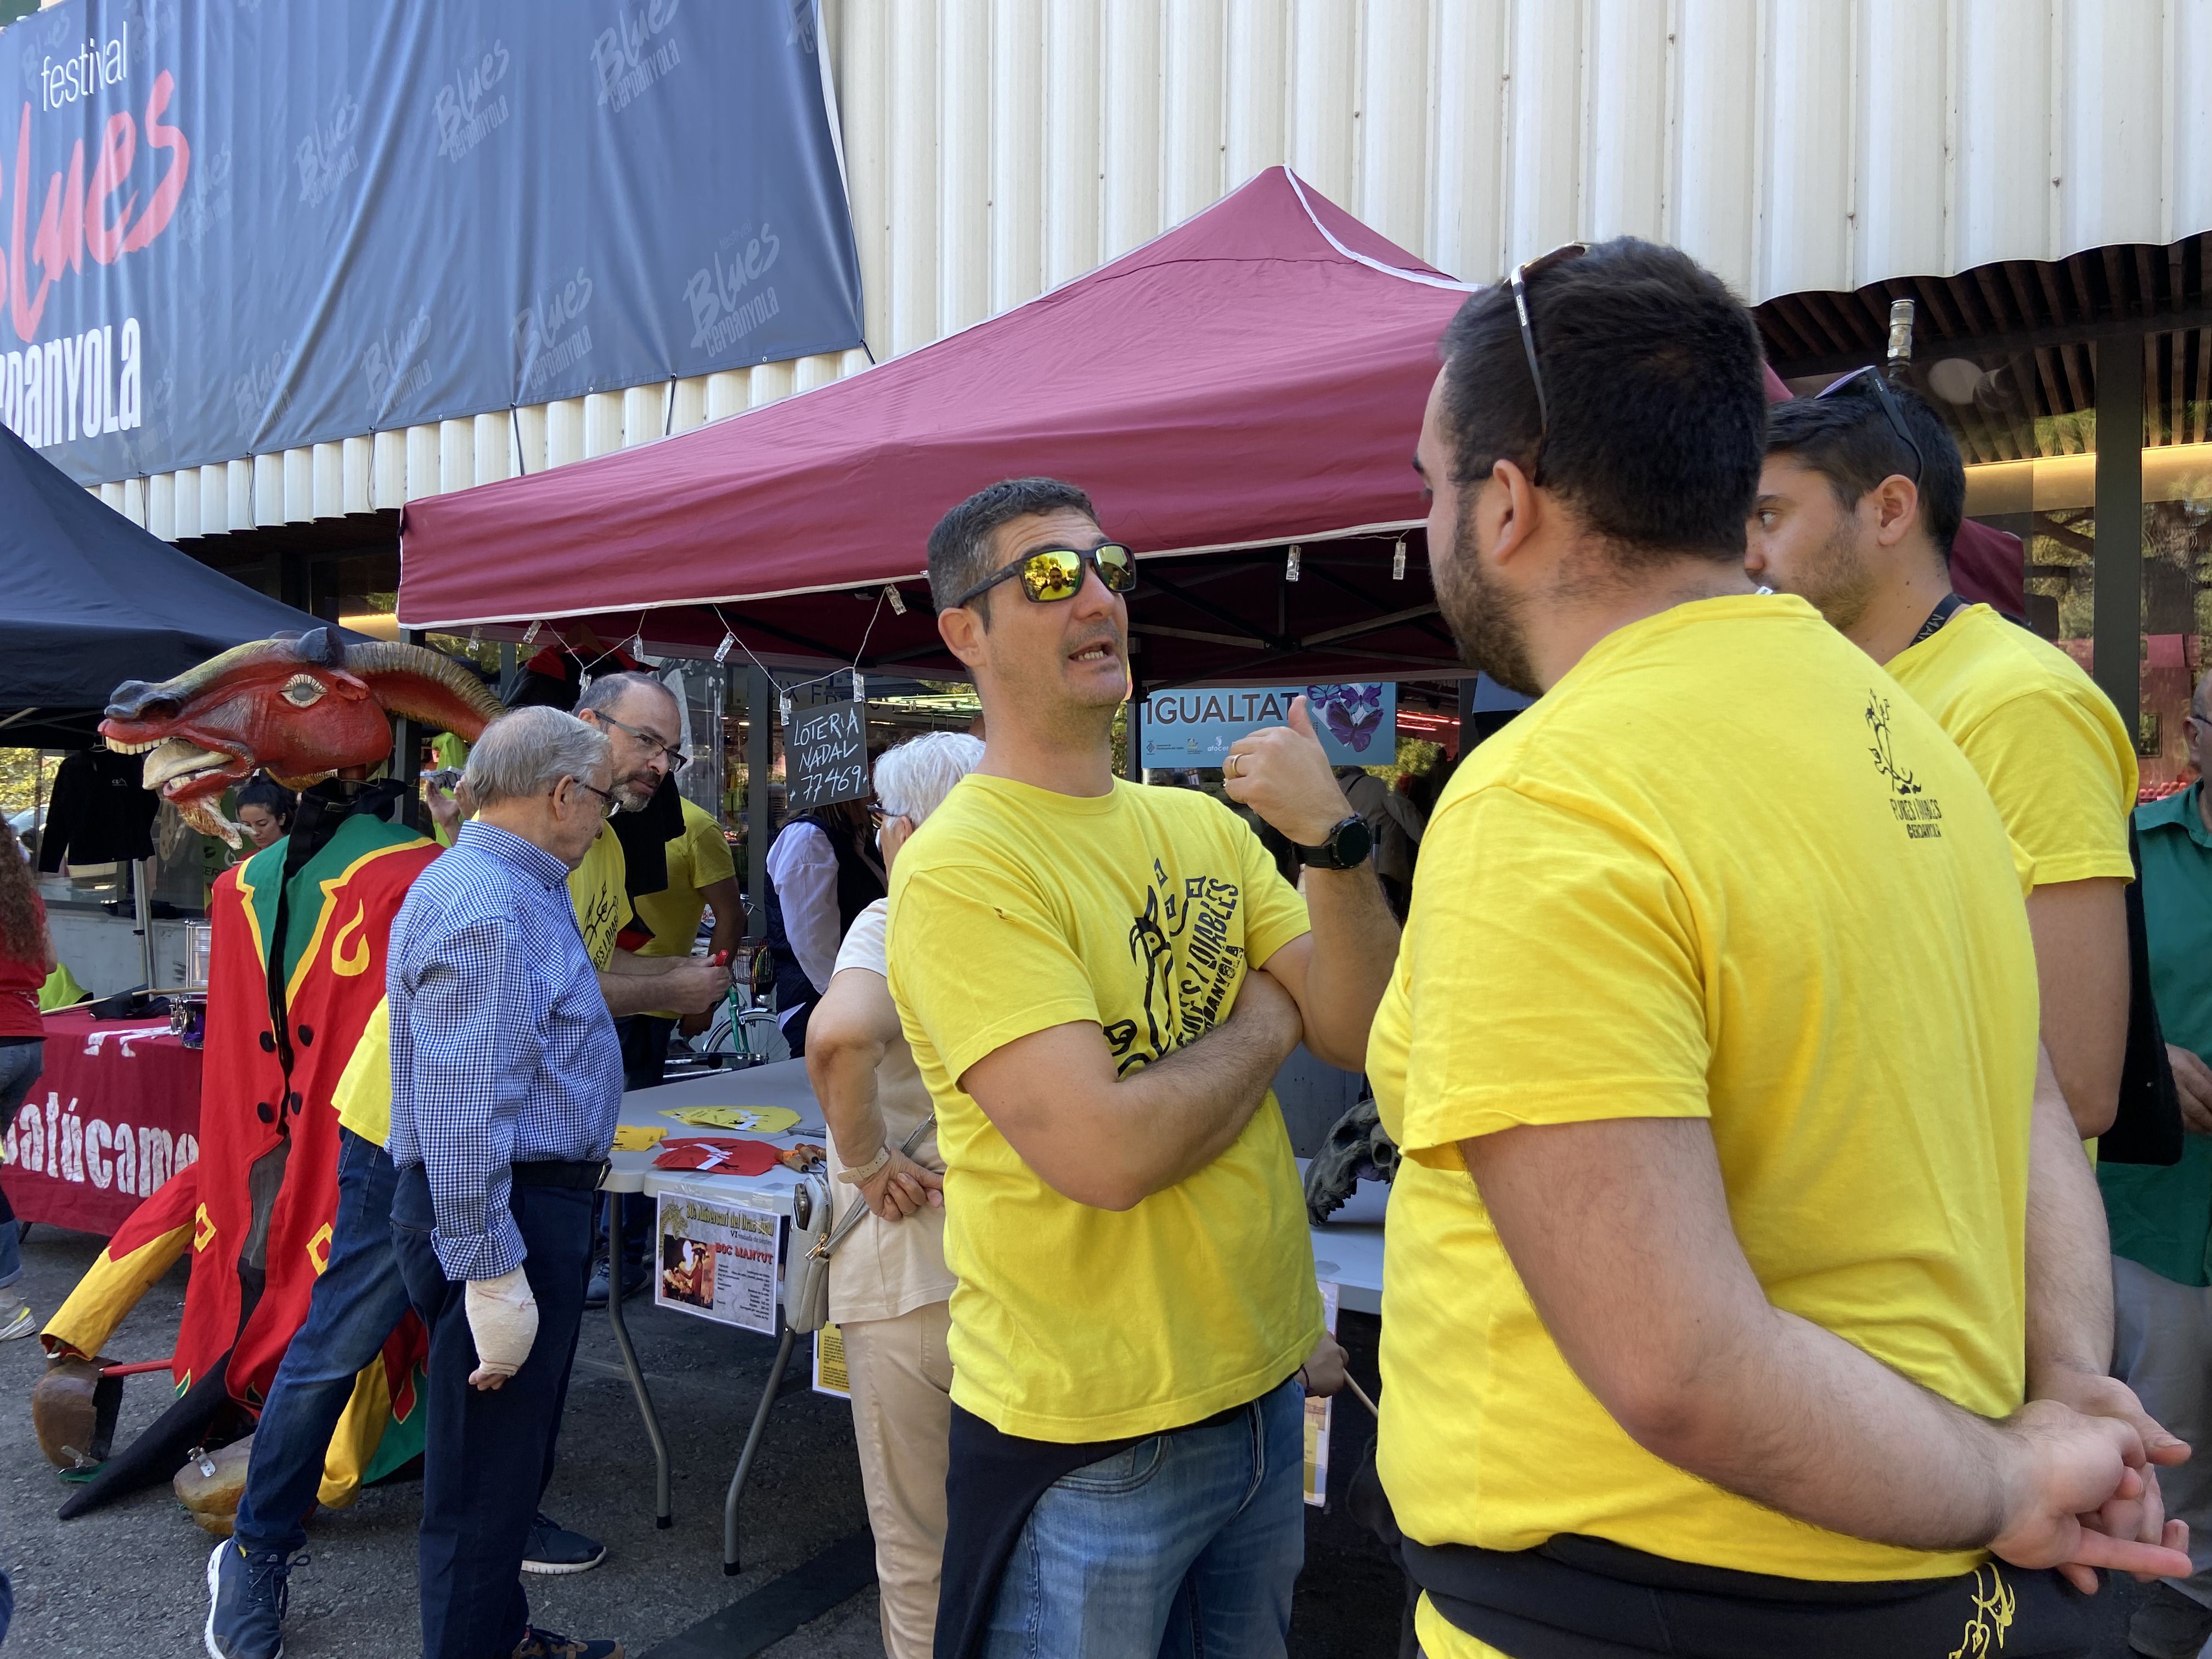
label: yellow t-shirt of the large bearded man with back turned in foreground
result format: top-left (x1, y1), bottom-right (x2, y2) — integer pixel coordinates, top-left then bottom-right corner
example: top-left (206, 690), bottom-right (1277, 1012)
top-left (1367, 595), bottom-right (2037, 1659)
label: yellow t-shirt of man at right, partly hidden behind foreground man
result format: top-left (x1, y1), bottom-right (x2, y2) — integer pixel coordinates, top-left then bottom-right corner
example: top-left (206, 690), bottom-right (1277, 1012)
top-left (1887, 604), bottom-right (2137, 887)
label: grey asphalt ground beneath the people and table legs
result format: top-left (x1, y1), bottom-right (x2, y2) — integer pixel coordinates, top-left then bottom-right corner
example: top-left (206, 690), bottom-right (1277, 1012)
top-left (0, 1228), bottom-right (1400, 1659)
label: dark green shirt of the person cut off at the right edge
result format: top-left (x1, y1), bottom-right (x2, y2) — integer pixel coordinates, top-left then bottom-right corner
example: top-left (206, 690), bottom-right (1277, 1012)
top-left (2097, 778), bottom-right (2212, 1285)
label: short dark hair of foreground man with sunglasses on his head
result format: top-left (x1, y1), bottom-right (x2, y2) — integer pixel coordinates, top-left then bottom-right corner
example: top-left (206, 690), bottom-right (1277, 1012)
top-left (1438, 236), bottom-right (1768, 564)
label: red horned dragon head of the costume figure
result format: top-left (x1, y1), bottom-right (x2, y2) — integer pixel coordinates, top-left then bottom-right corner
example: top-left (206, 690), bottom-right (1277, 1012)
top-left (99, 628), bottom-right (502, 847)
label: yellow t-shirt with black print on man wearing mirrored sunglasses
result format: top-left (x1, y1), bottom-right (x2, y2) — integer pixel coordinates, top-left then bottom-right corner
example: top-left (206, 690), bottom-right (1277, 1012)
top-left (889, 774), bottom-right (1321, 1442)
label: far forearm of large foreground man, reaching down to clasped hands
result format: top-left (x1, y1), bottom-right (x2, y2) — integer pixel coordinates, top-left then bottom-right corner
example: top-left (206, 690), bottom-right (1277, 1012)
top-left (2028, 1053), bottom-right (2113, 1398)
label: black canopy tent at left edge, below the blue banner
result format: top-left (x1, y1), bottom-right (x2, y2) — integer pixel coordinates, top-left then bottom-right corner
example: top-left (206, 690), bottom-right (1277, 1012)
top-left (0, 427), bottom-right (336, 746)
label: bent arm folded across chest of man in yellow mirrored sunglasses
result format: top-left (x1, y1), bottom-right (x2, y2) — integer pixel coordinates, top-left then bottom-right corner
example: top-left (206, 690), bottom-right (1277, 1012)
top-left (960, 971), bottom-right (1299, 1210)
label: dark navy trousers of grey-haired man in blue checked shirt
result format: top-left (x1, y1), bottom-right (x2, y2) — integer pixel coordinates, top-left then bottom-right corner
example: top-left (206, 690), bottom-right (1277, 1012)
top-left (392, 1164), bottom-right (593, 1659)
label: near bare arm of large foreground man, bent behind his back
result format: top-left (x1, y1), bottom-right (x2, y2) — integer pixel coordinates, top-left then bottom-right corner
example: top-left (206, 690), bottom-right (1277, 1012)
top-left (1460, 1117), bottom-right (2186, 1571)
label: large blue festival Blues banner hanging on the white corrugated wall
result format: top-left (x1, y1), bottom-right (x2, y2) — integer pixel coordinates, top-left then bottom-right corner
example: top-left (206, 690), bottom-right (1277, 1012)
top-left (0, 0), bottom-right (860, 482)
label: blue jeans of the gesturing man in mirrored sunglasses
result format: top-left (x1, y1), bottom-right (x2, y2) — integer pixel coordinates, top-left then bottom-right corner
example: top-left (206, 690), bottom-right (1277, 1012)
top-left (982, 1378), bottom-right (1305, 1659)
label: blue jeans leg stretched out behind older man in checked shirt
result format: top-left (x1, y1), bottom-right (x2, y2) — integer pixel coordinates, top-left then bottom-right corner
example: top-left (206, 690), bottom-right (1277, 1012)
top-left (236, 1128), bottom-right (407, 1555)
